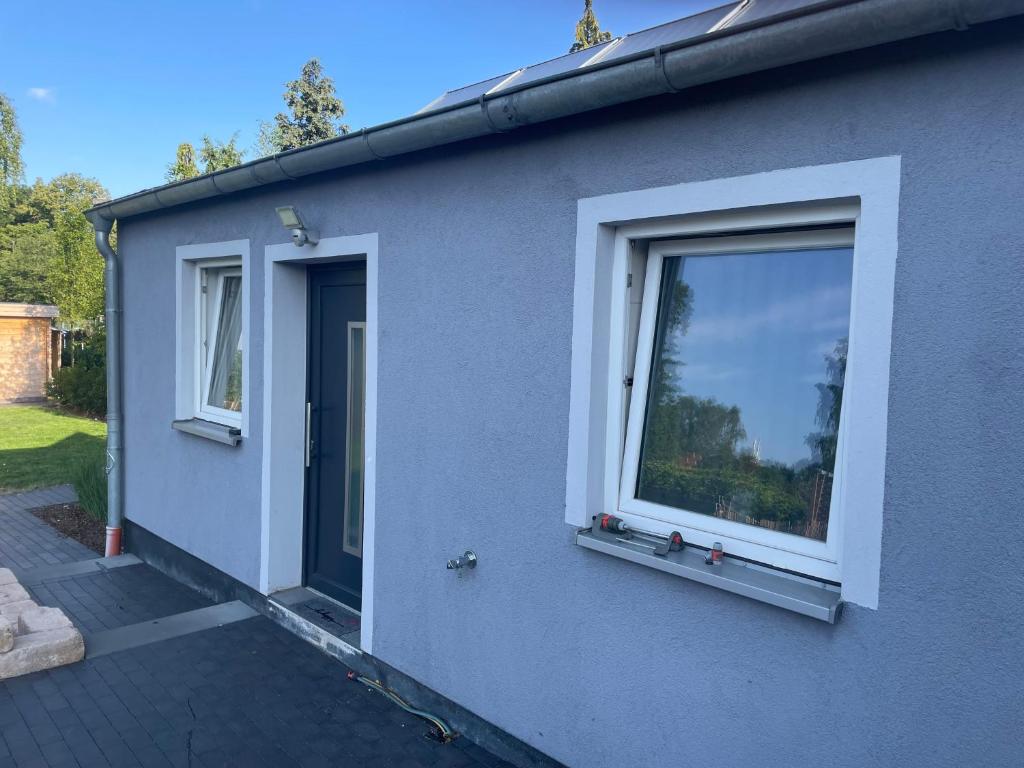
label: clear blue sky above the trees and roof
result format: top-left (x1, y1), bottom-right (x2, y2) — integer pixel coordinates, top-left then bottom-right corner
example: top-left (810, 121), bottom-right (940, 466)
top-left (0, 0), bottom-right (723, 196)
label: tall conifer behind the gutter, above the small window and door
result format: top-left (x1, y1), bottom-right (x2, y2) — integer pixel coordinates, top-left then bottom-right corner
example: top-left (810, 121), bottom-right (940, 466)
top-left (257, 58), bottom-right (348, 156)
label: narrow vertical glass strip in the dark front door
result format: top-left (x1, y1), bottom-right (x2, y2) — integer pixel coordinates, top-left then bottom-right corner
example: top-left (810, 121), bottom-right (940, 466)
top-left (342, 323), bottom-right (367, 557)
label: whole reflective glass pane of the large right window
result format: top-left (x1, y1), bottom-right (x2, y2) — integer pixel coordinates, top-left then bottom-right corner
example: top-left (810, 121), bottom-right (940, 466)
top-left (636, 248), bottom-right (853, 541)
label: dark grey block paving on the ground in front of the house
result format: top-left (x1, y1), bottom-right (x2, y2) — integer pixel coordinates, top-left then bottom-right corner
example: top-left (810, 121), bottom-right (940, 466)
top-left (0, 492), bottom-right (508, 768)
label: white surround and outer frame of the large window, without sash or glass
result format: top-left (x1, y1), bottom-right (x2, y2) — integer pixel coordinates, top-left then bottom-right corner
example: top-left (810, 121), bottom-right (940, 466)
top-left (565, 158), bottom-right (900, 608)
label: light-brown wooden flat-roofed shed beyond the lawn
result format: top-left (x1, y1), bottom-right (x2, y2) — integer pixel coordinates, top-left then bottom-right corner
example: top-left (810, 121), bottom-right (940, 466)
top-left (0, 302), bottom-right (60, 402)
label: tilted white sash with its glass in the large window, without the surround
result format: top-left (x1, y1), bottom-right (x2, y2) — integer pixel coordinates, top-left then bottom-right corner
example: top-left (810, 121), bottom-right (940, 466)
top-left (609, 228), bottom-right (854, 581)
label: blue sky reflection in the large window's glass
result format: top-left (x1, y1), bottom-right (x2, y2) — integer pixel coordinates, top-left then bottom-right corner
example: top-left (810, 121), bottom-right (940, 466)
top-left (670, 248), bottom-right (853, 464)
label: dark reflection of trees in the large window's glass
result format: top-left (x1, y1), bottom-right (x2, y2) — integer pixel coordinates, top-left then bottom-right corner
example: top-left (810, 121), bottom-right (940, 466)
top-left (637, 259), bottom-right (847, 541)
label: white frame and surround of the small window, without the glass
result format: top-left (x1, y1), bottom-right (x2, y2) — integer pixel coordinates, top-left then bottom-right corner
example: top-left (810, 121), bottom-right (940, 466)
top-left (174, 240), bottom-right (251, 437)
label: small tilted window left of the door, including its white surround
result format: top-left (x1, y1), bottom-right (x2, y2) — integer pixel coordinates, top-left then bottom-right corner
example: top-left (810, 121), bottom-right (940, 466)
top-left (175, 240), bottom-right (249, 442)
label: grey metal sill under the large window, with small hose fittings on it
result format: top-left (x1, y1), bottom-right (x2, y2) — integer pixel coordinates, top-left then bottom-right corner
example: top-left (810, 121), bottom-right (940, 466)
top-left (577, 528), bottom-right (842, 624)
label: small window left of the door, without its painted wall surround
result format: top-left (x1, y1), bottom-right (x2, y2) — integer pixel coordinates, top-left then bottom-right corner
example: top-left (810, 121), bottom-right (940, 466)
top-left (195, 260), bottom-right (245, 428)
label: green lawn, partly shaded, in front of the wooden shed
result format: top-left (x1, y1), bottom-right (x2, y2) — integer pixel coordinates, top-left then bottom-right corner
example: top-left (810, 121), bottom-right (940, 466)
top-left (0, 406), bottom-right (106, 492)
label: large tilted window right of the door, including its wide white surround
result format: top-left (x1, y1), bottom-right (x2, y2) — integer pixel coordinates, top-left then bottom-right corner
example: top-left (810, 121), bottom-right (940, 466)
top-left (565, 158), bottom-right (899, 607)
